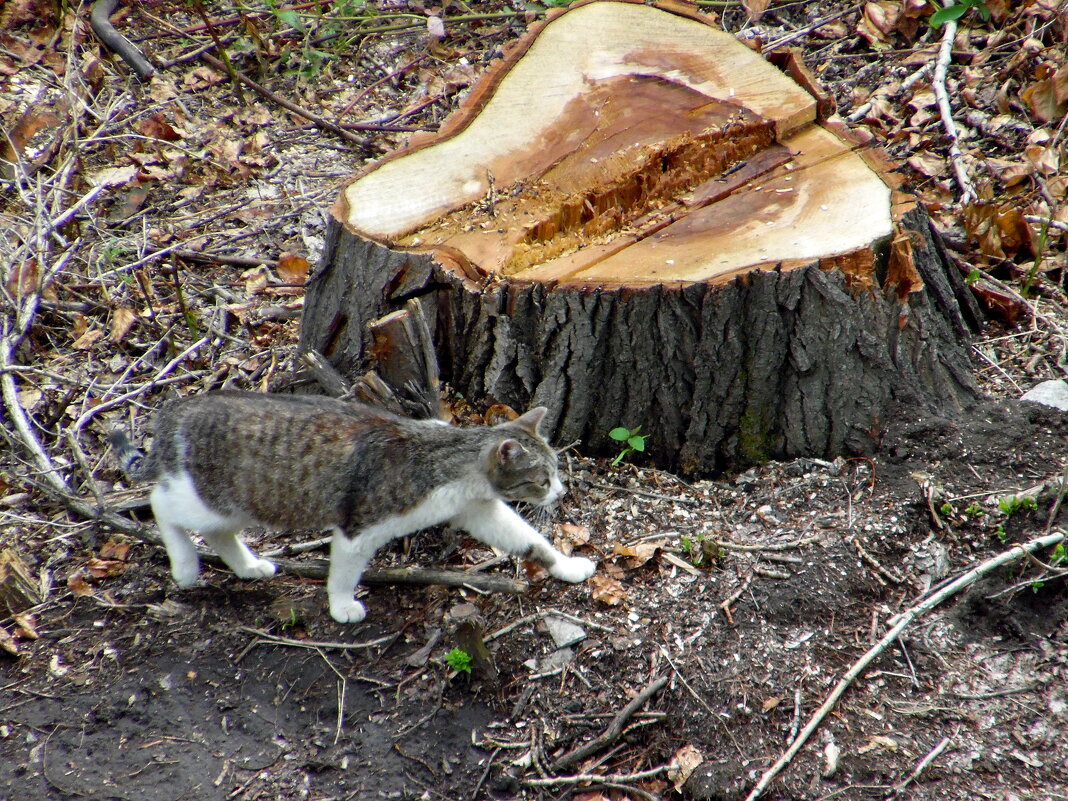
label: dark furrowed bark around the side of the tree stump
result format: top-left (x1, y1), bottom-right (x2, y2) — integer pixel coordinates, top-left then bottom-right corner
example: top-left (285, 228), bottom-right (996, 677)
top-left (302, 203), bottom-right (978, 473)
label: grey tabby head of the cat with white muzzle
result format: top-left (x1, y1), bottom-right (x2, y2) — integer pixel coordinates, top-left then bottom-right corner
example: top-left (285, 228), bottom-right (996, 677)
top-left (488, 406), bottom-right (564, 506)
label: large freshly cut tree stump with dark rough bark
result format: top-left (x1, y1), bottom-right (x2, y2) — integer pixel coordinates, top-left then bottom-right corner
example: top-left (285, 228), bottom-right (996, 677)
top-left (301, 0), bottom-right (978, 472)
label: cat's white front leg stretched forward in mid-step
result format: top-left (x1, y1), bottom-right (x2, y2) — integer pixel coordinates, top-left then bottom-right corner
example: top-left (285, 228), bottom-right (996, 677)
top-left (452, 501), bottom-right (597, 584)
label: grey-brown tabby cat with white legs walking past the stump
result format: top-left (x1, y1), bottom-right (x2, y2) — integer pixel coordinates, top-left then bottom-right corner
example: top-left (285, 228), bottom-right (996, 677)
top-left (109, 391), bottom-right (596, 623)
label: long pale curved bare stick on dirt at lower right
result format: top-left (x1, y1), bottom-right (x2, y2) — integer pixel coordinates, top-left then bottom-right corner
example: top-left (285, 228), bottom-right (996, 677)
top-left (745, 532), bottom-right (1065, 801)
